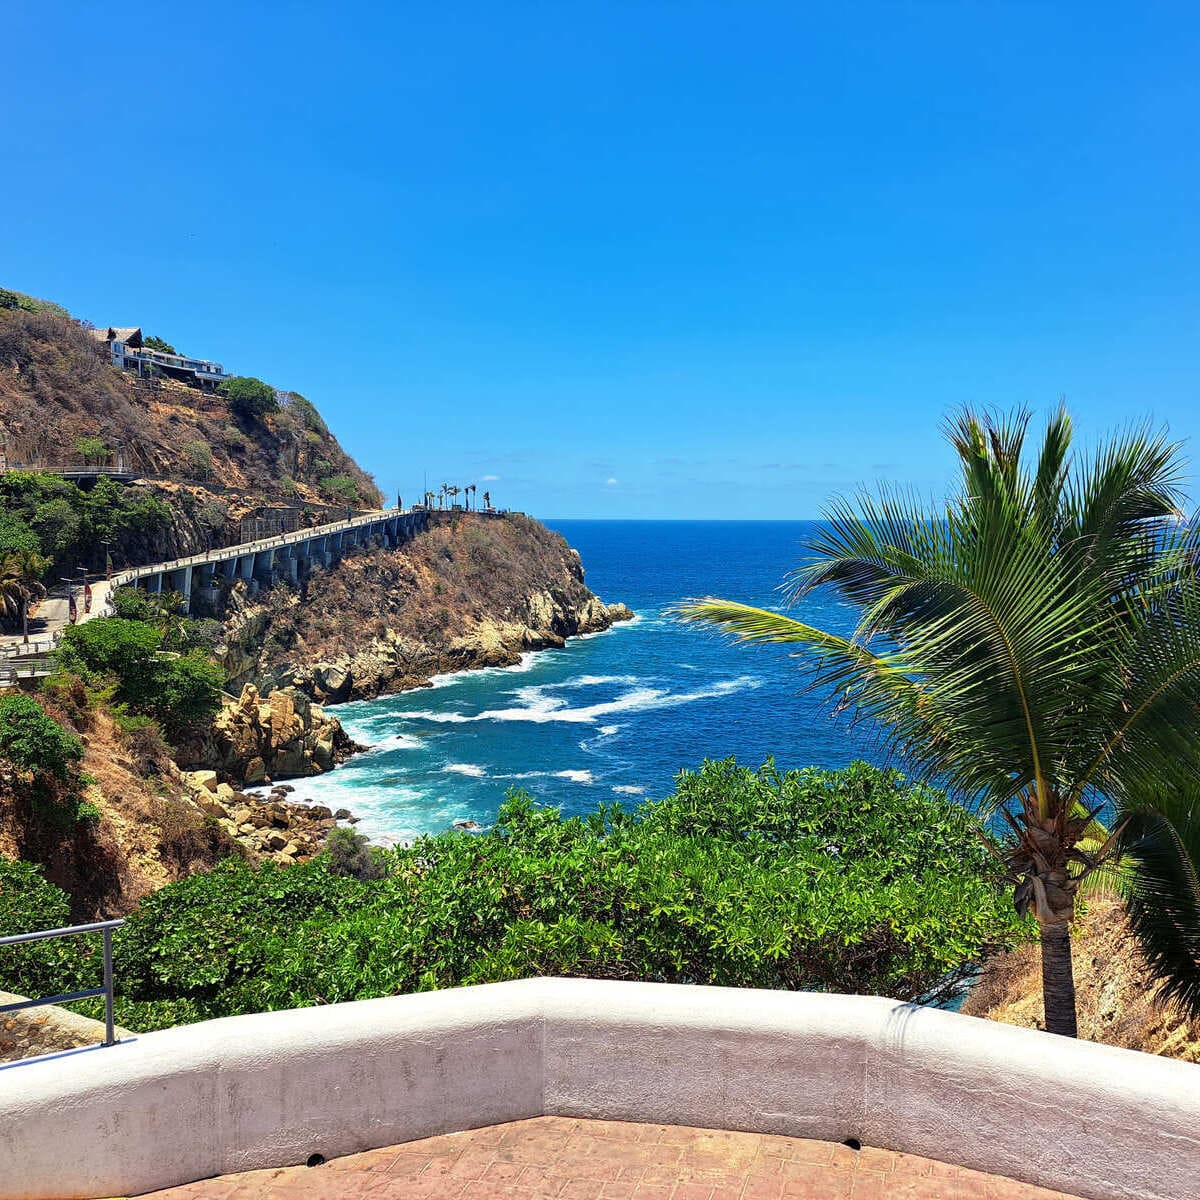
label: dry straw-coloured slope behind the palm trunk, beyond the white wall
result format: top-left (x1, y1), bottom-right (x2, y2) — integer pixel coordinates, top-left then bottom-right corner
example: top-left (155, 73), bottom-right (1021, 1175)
top-left (962, 899), bottom-right (1200, 1062)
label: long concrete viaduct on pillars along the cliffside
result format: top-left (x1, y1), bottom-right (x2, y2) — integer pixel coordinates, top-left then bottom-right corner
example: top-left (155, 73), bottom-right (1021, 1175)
top-left (105, 509), bottom-right (432, 616)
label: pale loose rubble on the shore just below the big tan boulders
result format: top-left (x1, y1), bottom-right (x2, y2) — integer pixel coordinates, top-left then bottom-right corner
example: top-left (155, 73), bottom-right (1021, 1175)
top-left (182, 770), bottom-right (358, 864)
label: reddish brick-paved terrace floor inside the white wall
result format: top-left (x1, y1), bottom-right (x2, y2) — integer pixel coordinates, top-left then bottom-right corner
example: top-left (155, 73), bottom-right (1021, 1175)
top-left (133, 1117), bottom-right (1089, 1200)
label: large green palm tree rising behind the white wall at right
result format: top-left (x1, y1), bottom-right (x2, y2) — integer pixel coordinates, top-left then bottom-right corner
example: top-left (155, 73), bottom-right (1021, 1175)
top-left (679, 410), bottom-right (1200, 1036)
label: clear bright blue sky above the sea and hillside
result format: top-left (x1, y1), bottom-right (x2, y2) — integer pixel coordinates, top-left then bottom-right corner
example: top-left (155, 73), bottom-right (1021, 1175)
top-left (0, 0), bottom-right (1200, 517)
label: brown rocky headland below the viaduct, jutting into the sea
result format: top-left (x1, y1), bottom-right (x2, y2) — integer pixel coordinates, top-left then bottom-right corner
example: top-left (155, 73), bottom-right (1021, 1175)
top-left (218, 514), bottom-right (632, 702)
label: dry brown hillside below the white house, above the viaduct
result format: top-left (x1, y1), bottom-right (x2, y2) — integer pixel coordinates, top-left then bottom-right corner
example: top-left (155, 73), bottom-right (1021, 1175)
top-left (0, 300), bottom-right (380, 550)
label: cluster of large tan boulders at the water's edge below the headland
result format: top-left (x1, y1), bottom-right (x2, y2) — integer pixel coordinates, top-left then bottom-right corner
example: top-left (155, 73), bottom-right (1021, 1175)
top-left (178, 684), bottom-right (362, 786)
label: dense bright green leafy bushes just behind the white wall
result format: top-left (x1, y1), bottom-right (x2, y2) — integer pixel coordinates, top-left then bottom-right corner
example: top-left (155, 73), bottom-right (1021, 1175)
top-left (0, 761), bottom-right (1021, 1028)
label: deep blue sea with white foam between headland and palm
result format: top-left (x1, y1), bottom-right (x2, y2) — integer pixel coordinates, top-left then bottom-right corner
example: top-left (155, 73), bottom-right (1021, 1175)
top-left (283, 521), bottom-right (874, 841)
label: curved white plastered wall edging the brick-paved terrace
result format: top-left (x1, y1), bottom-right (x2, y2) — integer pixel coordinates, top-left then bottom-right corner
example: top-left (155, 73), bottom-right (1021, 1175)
top-left (0, 979), bottom-right (1200, 1200)
